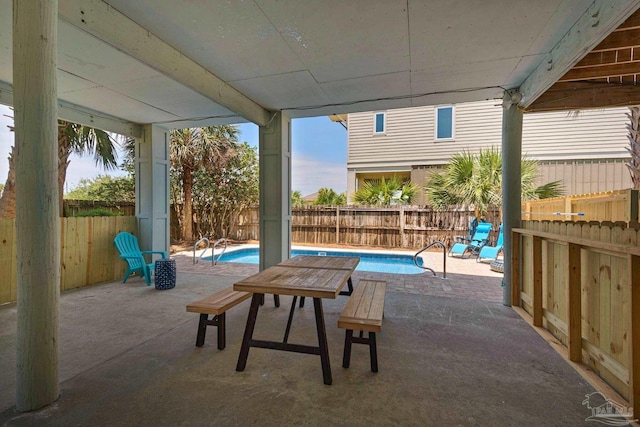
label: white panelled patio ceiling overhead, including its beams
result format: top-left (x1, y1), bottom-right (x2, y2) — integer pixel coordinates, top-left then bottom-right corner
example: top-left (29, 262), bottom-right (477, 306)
top-left (0, 0), bottom-right (640, 136)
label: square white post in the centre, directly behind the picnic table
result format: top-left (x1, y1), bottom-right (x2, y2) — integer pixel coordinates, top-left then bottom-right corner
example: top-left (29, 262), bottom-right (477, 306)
top-left (259, 112), bottom-right (291, 271)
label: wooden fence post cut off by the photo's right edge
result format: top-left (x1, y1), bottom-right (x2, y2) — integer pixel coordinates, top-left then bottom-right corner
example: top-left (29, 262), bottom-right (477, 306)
top-left (628, 255), bottom-right (640, 418)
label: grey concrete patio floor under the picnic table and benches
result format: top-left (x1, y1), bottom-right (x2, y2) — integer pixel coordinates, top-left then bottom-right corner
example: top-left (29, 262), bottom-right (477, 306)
top-left (0, 255), bottom-right (608, 426)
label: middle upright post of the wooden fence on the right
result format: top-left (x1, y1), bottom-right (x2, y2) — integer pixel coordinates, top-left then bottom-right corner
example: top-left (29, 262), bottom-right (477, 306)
top-left (567, 243), bottom-right (582, 362)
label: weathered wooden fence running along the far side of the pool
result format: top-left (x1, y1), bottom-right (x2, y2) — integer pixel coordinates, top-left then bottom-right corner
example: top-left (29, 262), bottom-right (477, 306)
top-left (228, 206), bottom-right (500, 249)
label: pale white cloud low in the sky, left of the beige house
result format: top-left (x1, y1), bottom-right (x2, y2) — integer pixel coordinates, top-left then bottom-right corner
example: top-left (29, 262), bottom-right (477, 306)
top-left (291, 155), bottom-right (347, 196)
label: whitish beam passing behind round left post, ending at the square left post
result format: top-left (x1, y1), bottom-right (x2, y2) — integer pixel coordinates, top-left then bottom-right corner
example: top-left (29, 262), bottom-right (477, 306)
top-left (0, 81), bottom-right (142, 138)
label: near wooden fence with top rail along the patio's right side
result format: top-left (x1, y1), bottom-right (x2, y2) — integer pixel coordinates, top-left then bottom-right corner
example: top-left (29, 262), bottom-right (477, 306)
top-left (512, 221), bottom-right (640, 416)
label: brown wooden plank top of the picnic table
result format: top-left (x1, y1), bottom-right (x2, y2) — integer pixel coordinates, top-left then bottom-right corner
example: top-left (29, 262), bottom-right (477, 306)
top-left (233, 264), bottom-right (357, 299)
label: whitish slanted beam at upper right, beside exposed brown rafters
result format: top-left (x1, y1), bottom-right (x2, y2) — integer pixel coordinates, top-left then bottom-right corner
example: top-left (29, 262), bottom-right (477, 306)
top-left (520, 0), bottom-right (640, 109)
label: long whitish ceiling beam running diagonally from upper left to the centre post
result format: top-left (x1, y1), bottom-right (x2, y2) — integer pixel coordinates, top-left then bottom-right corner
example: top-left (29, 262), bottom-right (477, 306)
top-left (58, 0), bottom-right (270, 126)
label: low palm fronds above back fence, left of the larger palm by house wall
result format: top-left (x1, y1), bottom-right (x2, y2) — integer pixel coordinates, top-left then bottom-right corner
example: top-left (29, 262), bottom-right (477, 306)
top-left (353, 175), bottom-right (420, 206)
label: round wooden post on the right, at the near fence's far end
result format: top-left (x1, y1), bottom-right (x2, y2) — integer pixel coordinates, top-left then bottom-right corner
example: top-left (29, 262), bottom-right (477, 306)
top-left (502, 90), bottom-right (522, 306)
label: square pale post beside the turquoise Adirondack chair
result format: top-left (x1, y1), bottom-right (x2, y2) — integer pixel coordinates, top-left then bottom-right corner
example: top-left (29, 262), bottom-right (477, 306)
top-left (135, 125), bottom-right (170, 261)
